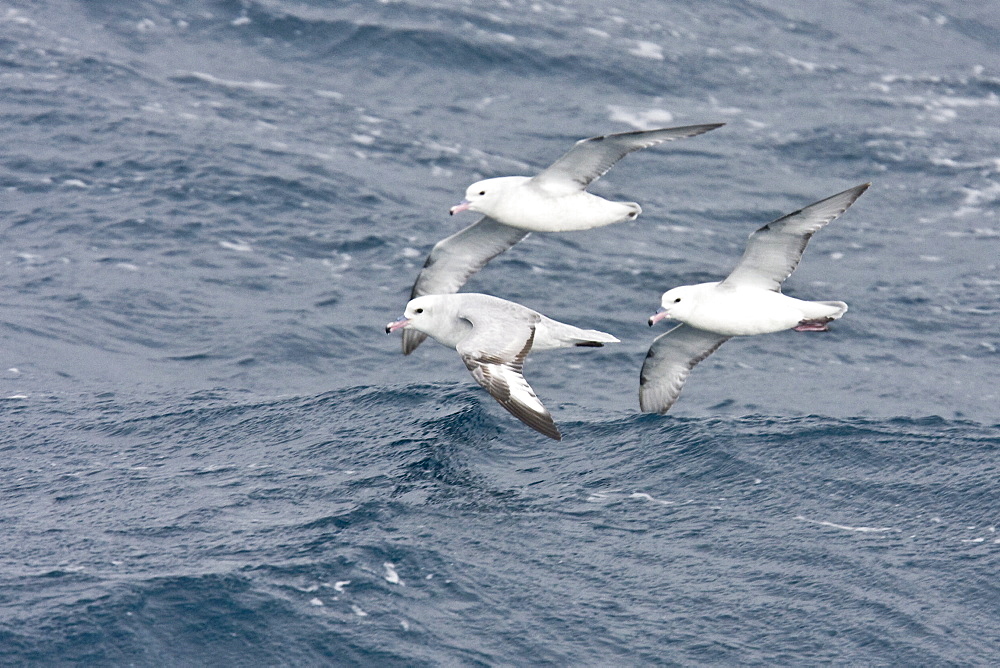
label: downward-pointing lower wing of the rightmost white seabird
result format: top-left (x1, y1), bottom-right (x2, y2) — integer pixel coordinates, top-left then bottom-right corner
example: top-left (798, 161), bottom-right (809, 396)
top-left (639, 325), bottom-right (729, 415)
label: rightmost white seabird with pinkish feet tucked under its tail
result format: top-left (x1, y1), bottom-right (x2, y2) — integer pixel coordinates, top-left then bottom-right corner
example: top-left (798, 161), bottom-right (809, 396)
top-left (639, 183), bottom-right (871, 414)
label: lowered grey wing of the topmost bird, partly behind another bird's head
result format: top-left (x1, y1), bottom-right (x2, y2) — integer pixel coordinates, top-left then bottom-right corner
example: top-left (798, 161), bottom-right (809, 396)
top-left (403, 217), bottom-right (528, 355)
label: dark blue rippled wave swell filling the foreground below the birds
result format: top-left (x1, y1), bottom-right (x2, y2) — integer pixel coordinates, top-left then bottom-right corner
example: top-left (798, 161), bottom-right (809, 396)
top-left (3, 384), bottom-right (1000, 665)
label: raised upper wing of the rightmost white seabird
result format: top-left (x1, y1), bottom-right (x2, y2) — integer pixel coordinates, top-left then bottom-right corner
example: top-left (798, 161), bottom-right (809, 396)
top-left (723, 183), bottom-right (871, 291)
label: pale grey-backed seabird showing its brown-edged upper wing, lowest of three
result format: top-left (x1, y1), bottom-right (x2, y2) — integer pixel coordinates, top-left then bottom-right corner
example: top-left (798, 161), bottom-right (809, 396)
top-left (385, 292), bottom-right (618, 441)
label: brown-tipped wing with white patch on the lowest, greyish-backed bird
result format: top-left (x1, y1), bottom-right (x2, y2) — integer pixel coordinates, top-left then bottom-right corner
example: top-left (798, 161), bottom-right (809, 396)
top-left (458, 326), bottom-right (562, 441)
